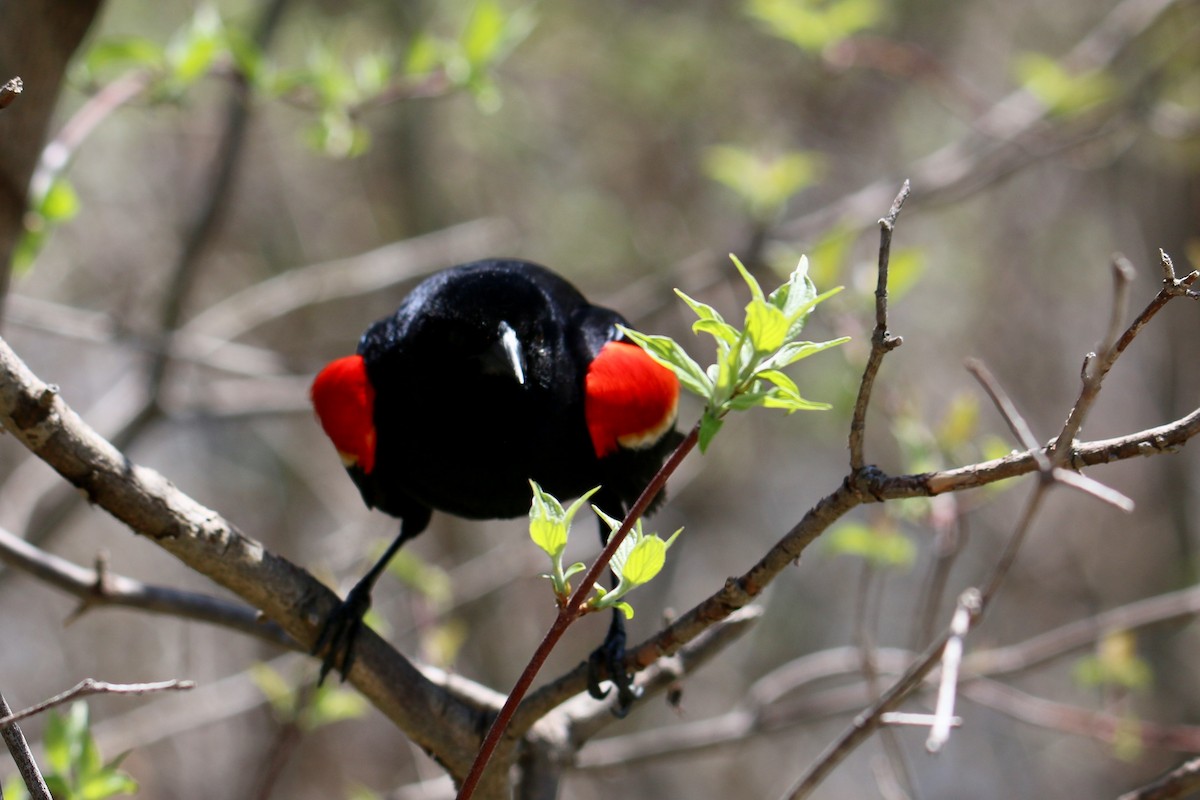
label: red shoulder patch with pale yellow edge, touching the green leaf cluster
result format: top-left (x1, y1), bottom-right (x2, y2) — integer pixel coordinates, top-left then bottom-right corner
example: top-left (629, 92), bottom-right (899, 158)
top-left (583, 342), bottom-right (679, 458)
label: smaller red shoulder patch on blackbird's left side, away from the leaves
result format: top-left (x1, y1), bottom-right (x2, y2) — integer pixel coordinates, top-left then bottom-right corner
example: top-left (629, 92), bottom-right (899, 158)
top-left (308, 355), bottom-right (376, 475)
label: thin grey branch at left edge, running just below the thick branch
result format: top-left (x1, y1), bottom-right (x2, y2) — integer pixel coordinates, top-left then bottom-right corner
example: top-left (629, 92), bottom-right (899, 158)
top-left (0, 528), bottom-right (296, 648)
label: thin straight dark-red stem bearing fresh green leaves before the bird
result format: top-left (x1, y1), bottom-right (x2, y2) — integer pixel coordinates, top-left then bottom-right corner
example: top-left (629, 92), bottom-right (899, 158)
top-left (458, 422), bottom-right (700, 800)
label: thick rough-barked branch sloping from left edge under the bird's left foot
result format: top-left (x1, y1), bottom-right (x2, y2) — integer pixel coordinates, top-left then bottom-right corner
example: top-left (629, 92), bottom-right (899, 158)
top-left (0, 333), bottom-right (492, 774)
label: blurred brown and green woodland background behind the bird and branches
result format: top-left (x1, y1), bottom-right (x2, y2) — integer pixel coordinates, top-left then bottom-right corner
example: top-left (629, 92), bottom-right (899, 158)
top-left (0, 0), bottom-right (1200, 799)
